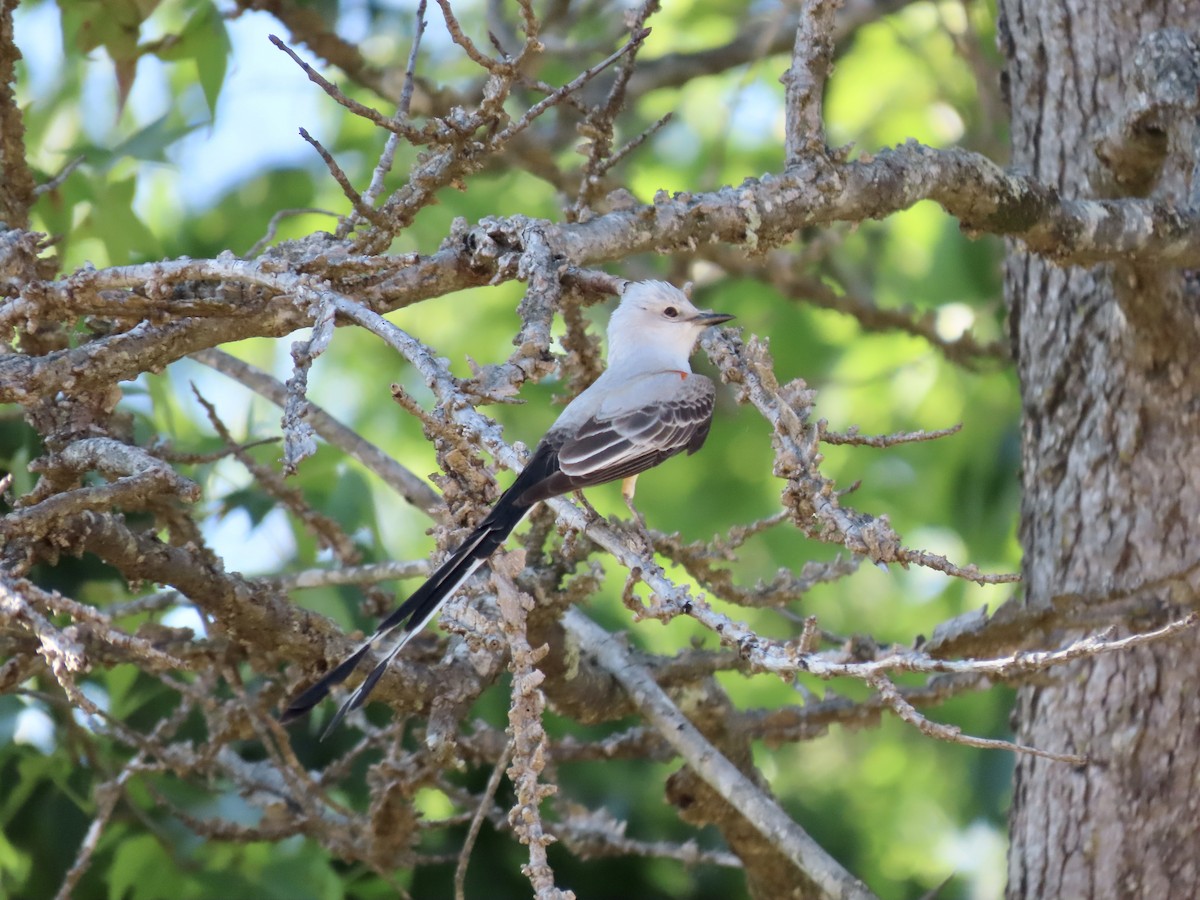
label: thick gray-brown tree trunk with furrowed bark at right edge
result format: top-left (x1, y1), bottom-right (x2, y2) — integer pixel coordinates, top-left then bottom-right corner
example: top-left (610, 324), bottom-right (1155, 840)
top-left (1000, 0), bottom-right (1200, 898)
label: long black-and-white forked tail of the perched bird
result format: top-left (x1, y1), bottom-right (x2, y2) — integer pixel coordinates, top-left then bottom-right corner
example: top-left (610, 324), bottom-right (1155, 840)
top-left (280, 494), bottom-right (529, 740)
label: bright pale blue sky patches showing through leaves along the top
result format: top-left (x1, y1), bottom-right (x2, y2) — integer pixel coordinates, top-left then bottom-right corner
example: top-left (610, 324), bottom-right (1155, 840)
top-left (14, 0), bottom-right (781, 212)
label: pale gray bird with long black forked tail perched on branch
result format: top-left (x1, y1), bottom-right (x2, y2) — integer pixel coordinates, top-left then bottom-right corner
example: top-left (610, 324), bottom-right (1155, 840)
top-left (281, 281), bottom-right (733, 734)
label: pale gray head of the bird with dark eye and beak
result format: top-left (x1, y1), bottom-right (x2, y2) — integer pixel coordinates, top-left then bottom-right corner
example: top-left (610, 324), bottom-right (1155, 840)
top-left (608, 281), bottom-right (733, 368)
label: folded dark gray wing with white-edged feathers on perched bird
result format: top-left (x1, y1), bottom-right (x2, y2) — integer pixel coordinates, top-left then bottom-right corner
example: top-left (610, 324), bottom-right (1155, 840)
top-left (542, 373), bottom-right (715, 501)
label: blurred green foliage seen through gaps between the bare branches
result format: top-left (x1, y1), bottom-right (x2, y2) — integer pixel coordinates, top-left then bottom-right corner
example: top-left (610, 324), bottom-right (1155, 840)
top-left (0, 0), bottom-right (1019, 900)
